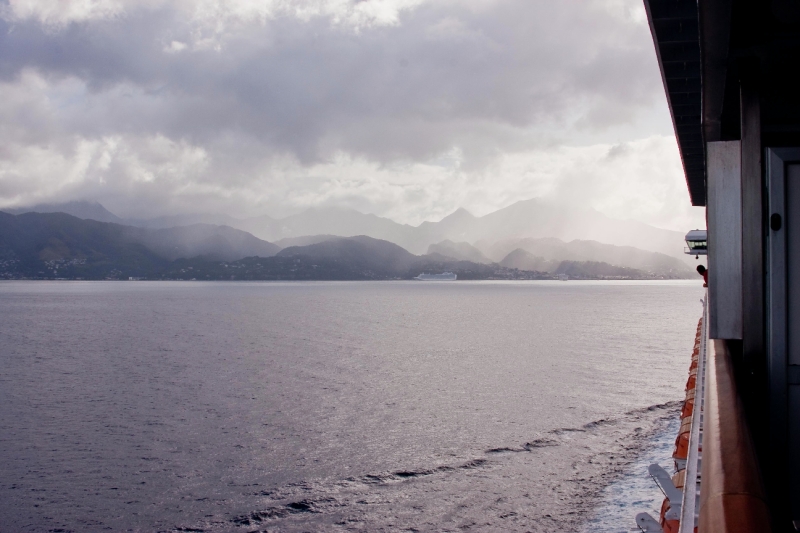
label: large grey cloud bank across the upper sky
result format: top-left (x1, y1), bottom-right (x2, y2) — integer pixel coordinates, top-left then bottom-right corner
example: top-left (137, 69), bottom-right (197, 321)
top-left (0, 0), bottom-right (660, 163)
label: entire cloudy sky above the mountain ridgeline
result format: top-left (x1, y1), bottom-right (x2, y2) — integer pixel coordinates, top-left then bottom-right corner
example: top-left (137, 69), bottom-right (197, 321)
top-left (0, 0), bottom-right (704, 230)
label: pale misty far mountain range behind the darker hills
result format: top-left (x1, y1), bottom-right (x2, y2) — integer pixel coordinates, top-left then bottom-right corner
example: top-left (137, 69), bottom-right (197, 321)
top-left (6, 199), bottom-right (693, 265)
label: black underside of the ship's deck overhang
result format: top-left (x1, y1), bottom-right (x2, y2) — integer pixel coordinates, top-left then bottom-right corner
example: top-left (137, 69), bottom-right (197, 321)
top-left (644, 0), bottom-right (800, 205)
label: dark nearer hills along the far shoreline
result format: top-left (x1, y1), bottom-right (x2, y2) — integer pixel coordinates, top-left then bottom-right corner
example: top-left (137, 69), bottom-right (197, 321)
top-left (0, 213), bottom-right (692, 280)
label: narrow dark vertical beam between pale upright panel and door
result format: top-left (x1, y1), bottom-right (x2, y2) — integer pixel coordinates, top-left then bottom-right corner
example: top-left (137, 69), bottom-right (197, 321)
top-left (740, 65), bottom-right (765, 378)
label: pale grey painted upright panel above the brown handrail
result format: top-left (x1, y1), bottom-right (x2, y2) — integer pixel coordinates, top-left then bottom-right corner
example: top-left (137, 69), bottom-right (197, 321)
top-left (706, 141), bottom-right (742, 339)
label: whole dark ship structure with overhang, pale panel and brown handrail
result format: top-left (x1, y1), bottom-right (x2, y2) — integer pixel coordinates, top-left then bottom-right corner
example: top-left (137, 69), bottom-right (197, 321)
top-left (637, 0), bottom-right (800, 533)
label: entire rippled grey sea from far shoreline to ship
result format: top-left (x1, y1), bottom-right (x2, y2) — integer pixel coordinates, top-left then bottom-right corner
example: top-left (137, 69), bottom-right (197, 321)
top-left (0, 281), bottom-right (703, 532)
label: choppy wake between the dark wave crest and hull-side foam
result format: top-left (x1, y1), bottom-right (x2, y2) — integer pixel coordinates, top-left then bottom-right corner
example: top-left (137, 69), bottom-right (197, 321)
top-left (174, 402), bottom-right (680, 532)
